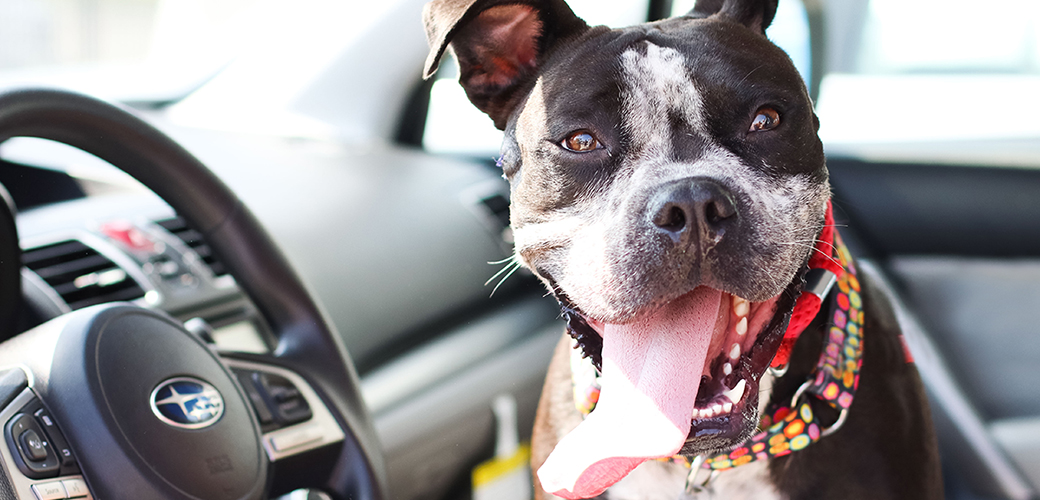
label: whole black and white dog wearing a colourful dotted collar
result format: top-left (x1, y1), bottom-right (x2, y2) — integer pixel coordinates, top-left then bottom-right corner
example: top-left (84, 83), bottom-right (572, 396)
top-left (424, 0), bottom-right (942, 500)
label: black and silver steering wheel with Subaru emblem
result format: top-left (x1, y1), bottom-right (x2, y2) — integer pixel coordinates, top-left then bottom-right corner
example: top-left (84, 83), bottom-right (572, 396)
top-left (0, 89), bottom-right (387, 500)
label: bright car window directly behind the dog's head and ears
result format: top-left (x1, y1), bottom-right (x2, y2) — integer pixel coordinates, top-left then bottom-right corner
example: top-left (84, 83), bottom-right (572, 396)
top-left (422, 0), bottom-right (810, 158)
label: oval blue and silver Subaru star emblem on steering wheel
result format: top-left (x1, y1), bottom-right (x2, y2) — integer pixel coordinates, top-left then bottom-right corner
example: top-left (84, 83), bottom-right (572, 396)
top-left (149, 376), bottom-right (224, 429)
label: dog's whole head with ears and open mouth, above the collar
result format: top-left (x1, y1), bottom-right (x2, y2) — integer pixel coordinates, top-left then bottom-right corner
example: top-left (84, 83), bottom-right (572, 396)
top-left (424, 0), bottom-right (830, 491)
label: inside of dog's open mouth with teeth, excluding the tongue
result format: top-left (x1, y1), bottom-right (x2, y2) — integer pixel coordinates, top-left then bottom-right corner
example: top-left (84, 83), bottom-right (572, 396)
top-left (557, 268), bottom-right (804, 456)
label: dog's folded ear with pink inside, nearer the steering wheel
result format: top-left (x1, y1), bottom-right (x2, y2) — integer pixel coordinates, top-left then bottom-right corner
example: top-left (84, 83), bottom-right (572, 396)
top-left (422, 0), bottom-right (589, 129)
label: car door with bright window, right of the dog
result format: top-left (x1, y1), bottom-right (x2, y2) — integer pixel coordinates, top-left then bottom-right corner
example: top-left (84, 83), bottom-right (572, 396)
top-left (807, 0), bottom-right (1040, 498)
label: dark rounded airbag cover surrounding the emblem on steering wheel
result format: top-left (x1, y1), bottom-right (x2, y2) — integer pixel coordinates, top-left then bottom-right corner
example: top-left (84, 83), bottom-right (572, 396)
top-left (49, 307), bottom-right (267, 499)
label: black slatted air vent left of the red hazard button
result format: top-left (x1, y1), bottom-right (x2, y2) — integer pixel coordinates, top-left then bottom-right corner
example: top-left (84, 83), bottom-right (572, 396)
top-left (22, 240), bottom-right (145, 310)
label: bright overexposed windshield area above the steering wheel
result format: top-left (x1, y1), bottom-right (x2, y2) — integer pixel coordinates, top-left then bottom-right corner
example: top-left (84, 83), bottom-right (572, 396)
top-left (0, 0), bottom-right (312, 102)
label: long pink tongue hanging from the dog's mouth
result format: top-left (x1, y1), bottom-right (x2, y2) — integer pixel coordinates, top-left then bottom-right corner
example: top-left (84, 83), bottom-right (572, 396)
top-left (538, 287), bottom-right (722, 499)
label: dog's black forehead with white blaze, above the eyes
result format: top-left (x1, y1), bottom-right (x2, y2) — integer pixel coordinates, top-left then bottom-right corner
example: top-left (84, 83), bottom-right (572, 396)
top-left (528, 23), bottom-right (808, 144)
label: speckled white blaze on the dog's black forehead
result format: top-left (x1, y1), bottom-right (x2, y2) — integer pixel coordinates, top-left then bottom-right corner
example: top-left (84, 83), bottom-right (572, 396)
top-left (621, 42), bottom-right (705, 156)
